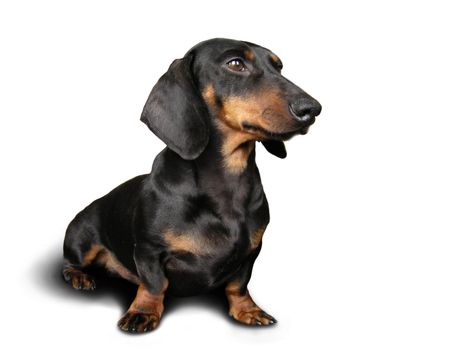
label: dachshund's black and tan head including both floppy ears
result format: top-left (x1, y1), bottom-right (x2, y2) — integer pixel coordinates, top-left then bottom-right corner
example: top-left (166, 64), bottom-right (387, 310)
top-left (141, 39), bottom-right (321, 159)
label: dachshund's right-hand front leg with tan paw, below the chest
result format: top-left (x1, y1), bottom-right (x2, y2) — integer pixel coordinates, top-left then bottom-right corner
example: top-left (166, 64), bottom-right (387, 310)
top-left (225, 248), bottom-right (277, 325)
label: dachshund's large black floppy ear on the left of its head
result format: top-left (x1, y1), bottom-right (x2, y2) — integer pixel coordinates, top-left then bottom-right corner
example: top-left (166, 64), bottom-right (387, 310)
top-left (141, 54), bottom-right (209, 160)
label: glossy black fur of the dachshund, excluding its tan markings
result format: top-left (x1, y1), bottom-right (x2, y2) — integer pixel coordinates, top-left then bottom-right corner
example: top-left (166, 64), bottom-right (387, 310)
top-left (64, 39), bottom-right (321, 330)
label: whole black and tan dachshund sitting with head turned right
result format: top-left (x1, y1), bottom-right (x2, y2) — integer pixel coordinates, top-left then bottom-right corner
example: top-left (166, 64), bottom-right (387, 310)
top-left (63, 39), bottom-right (321, 332)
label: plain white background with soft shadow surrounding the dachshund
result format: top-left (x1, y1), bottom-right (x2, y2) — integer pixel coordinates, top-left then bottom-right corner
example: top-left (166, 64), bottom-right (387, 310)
top-left (0, 0), bottom-right (467, 350)
